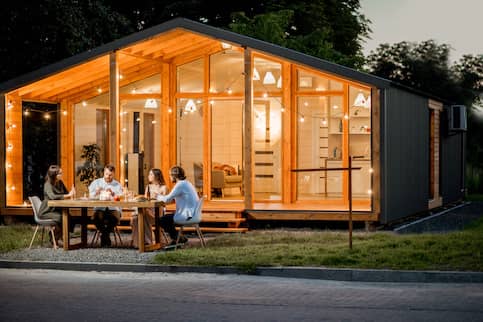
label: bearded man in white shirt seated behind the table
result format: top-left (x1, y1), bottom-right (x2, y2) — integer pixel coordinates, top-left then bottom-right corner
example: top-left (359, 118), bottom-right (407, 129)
top-left (89, 164), bottom-right (123, 247)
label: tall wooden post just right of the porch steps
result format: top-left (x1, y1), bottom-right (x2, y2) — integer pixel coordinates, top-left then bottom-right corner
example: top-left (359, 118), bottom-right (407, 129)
top-left (243, 48), bottom-right (253, 209)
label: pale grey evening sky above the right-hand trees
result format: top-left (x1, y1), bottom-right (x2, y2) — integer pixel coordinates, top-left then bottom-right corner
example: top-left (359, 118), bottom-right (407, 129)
top-left (360, 0), bottom-right (483, 62)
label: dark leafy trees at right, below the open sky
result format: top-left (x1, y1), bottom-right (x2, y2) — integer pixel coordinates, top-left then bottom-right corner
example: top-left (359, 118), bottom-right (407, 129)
top-left (367, 40), bottom-right (483, 192)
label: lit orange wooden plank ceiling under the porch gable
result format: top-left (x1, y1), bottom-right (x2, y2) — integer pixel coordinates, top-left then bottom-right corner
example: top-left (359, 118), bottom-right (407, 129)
top-left (9, 29), bottom-right (222, 103)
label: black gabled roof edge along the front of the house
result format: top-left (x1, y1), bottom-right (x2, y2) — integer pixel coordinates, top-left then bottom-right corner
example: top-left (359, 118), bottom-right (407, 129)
top-left (0, 18), bottom-right (418, 96)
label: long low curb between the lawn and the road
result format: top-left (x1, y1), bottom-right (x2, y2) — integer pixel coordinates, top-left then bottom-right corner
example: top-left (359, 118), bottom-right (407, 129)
top-left (0, 260), bottom-right (483, 283)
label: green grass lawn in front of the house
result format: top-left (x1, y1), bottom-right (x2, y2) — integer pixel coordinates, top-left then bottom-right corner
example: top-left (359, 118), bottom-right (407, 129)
top-left (0, 219), bottom-right (483, 271)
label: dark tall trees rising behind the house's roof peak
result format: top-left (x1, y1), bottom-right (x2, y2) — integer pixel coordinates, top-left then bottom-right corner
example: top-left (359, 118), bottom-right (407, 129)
top-left (0, 0), bottom-right (370, 81)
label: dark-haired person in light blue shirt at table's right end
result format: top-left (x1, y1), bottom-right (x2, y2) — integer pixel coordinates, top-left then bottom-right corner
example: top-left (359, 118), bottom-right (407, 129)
top-left (157, 166), bottom-right (199, 244)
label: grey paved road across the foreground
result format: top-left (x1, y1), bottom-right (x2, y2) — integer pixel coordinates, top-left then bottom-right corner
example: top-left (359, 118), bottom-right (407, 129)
top-left (0, 269), bottom-right (483, 322)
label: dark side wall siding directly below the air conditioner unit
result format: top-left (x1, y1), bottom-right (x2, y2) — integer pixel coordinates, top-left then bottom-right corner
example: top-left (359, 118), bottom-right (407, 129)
top-left (440, 130), bottom-right (466, 204)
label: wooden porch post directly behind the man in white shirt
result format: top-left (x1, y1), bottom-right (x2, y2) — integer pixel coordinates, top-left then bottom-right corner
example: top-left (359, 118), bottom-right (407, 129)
top-left (107, 52), bottom-right (121, 169)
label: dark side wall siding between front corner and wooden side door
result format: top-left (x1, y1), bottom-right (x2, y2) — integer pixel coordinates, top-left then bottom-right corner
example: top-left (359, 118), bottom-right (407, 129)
top-left (380, 88), bottom-right (429, 223)
